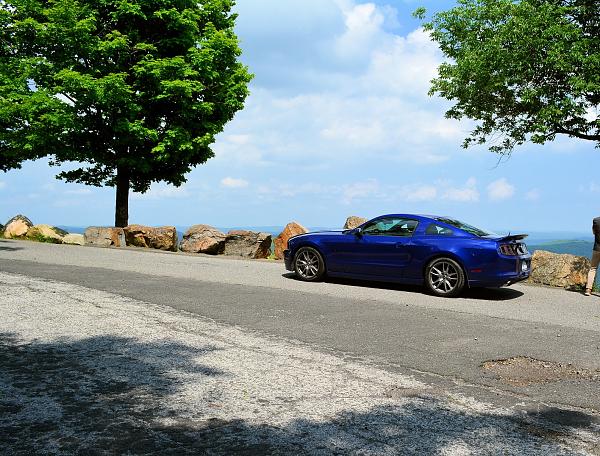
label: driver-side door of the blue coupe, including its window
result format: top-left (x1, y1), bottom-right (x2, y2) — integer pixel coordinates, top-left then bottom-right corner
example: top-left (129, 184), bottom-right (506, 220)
top-left (344, 217), bottom-right (418, 280)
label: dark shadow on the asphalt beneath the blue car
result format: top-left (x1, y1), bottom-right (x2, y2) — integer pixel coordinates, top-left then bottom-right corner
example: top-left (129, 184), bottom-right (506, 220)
top-left (282, 272), bottom-right (523, 301)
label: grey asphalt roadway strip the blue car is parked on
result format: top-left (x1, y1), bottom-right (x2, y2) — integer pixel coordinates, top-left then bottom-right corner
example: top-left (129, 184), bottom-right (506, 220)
top-left (0, 241), bottom-right (600, 422)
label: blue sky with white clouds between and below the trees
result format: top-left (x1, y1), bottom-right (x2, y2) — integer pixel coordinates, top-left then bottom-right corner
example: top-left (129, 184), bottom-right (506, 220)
top-left (0, 0), bottom-right (600, 232)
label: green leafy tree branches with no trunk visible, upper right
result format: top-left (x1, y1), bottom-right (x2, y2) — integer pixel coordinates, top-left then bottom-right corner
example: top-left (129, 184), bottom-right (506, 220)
top-left (416, 0), bottom-right (600, 154)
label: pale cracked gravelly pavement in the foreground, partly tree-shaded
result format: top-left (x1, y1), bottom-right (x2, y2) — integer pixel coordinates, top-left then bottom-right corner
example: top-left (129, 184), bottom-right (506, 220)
top-left (0, 272), bottom-right (600, 455)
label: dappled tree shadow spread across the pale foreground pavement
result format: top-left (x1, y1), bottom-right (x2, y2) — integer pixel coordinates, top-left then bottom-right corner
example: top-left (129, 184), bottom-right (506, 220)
top-left (0, 334), bottom-right (590, 455)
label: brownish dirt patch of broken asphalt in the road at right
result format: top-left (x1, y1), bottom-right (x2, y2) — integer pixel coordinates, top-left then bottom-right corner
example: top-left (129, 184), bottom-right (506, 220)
top-left (481, 356), bottom-right (600, 386)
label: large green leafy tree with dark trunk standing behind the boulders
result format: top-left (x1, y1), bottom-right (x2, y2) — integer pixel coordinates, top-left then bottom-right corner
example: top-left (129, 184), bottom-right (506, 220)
top-left (0, 0), bottom-right (251, 226)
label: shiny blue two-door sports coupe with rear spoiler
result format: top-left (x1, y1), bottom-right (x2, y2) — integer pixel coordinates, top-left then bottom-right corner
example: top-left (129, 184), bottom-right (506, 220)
top-left (284, 214), bottom-right (531, 297)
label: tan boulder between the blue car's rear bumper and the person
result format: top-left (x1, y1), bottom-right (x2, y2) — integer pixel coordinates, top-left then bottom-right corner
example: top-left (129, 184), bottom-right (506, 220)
top-left (529, 250), bottom-right (590, 290)
